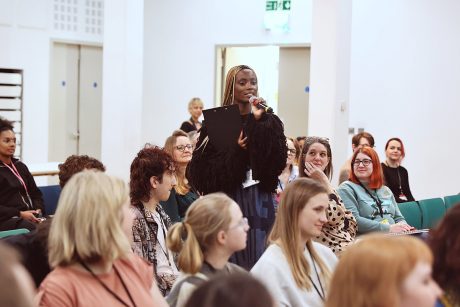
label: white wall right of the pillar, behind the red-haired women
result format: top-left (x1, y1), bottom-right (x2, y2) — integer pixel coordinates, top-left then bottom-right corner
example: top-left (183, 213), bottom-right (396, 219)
top-left (350, 0), bottom-right (460, 199)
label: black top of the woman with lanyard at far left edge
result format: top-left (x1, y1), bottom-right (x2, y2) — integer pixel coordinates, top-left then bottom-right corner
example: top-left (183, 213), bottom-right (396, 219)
top-left (0, 158), bottom-right (43, 222)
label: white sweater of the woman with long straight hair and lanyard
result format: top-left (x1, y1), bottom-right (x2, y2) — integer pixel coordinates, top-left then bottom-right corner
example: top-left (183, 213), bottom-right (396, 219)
top-left (251, 242), bottom-right (337, 307)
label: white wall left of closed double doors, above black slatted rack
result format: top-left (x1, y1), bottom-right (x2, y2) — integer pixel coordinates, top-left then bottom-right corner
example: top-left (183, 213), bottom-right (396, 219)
top-left (0, 0), bottom-right (50, 163)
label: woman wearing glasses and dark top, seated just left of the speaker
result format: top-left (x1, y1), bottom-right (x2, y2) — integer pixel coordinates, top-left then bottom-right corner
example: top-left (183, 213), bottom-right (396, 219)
top-left (160, 130), bottom-right (198, 222)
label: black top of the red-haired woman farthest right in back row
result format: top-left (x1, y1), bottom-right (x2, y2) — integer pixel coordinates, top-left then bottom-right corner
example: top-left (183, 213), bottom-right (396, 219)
top-left (382, 163), bottom-right (415, 203)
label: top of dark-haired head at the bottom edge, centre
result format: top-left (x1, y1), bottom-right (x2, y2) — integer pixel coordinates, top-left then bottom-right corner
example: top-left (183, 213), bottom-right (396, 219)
top-left (185, 273), bottom-right (276, 307)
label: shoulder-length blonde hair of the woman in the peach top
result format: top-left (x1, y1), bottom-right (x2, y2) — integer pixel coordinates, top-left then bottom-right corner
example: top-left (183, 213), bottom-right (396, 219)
top-left (48, 170), bottom-right (130, 267)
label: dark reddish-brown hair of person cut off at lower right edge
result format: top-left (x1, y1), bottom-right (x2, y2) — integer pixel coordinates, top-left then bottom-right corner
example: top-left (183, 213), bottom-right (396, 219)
top-left (428, 205), bottom-right (460, 307)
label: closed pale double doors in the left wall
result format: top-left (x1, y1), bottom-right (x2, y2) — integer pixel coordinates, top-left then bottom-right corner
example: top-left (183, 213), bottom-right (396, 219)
top-left (48, 43), bottom-right (102, 161)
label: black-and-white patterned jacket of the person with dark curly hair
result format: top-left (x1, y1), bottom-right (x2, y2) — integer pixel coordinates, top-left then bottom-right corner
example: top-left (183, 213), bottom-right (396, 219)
top-left (130, 204), bottom-right (177, 296)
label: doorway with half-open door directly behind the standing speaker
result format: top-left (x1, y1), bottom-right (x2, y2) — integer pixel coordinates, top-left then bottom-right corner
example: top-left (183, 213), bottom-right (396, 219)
top-left (215, 46), bottom-right (310, 137)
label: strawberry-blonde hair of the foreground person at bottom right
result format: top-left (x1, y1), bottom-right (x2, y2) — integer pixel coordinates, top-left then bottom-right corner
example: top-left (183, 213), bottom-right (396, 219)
top-left (325, 234), bottom-right (433, 307)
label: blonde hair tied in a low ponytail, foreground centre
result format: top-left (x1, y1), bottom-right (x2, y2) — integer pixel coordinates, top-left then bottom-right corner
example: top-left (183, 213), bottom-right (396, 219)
top-left (167, 193), bottom-right (234, 274)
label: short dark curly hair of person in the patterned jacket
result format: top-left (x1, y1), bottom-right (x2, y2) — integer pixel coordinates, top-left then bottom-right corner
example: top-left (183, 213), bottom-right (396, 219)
top-left (129, 144), bottom-right (176, 206)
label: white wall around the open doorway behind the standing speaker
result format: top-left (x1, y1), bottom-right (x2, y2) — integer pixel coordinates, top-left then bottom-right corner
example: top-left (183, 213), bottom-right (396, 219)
top-left (142, 0), bottom-right (311, 145)
